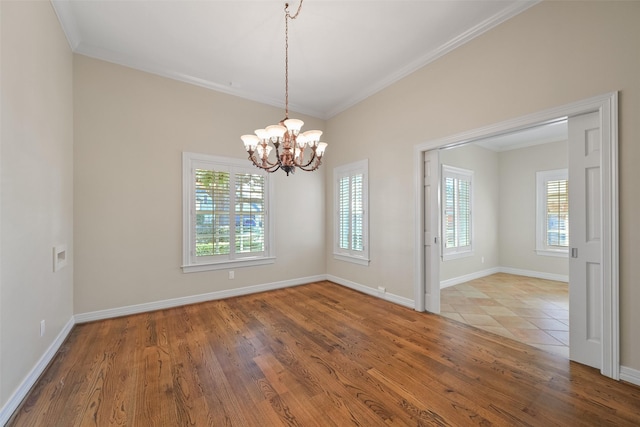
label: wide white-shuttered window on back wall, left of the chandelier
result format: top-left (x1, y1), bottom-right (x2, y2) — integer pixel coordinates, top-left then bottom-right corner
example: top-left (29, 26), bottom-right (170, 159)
top-left (182, 153), bottom-right (274, 273)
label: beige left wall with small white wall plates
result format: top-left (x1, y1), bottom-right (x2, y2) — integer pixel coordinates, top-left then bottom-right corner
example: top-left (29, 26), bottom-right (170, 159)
top-left (0, 1), bottom-right (73, 408)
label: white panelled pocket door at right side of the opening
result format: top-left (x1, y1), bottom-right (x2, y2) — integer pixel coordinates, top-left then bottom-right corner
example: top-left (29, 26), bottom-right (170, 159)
top-left (568, 113), bottom-right (603, 369)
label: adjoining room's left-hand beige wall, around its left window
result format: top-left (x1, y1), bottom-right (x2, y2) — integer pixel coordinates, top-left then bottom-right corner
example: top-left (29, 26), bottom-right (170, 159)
top-left (440, 145), bottom-right (500, 281)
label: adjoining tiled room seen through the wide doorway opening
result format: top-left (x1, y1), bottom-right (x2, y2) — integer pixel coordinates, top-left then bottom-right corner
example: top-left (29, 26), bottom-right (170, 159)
top-left (439, 120), bottom-right (570, 358)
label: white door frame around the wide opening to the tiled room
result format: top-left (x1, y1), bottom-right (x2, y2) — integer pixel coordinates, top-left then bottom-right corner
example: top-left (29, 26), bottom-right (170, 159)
top-left (413, 92), bottom-right (620, 380)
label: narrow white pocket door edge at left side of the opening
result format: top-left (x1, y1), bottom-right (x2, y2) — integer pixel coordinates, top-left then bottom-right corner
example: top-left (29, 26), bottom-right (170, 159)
top-left (423, 150), bottom-right (440, 313)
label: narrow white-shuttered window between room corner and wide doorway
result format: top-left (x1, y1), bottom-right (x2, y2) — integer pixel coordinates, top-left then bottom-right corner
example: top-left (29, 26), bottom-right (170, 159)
top-left (333, 160), bottom-right (369, 265)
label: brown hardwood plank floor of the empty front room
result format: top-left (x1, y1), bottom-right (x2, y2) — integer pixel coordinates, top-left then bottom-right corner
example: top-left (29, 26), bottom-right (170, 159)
top-left (8, 282), bottom-right (640, 427)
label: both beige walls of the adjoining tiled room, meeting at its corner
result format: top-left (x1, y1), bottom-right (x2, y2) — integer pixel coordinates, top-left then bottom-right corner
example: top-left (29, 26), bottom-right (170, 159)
top-left (440, 141), bottom-right (569, 281)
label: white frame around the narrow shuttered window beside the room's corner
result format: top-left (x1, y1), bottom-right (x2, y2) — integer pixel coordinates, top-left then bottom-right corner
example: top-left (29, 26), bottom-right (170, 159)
top-left (333, 159), bottom-right (371, 266)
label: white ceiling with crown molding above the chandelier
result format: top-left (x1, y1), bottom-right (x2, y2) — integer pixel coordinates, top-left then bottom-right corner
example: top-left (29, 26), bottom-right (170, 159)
top-left (52, 0), bottom-right (538, 119)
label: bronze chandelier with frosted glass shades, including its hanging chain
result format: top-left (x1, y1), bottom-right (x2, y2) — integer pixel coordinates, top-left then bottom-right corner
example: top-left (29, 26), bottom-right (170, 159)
top-left (240, 0), bottom-right (327, 176)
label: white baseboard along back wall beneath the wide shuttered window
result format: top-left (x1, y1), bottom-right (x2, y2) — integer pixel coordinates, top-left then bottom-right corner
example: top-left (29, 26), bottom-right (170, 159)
top-left (75, 275), bottom-right (325, 323)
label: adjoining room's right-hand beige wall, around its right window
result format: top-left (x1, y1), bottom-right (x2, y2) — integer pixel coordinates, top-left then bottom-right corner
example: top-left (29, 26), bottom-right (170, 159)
top-left (499, 141), bottom-right (569, 276)
